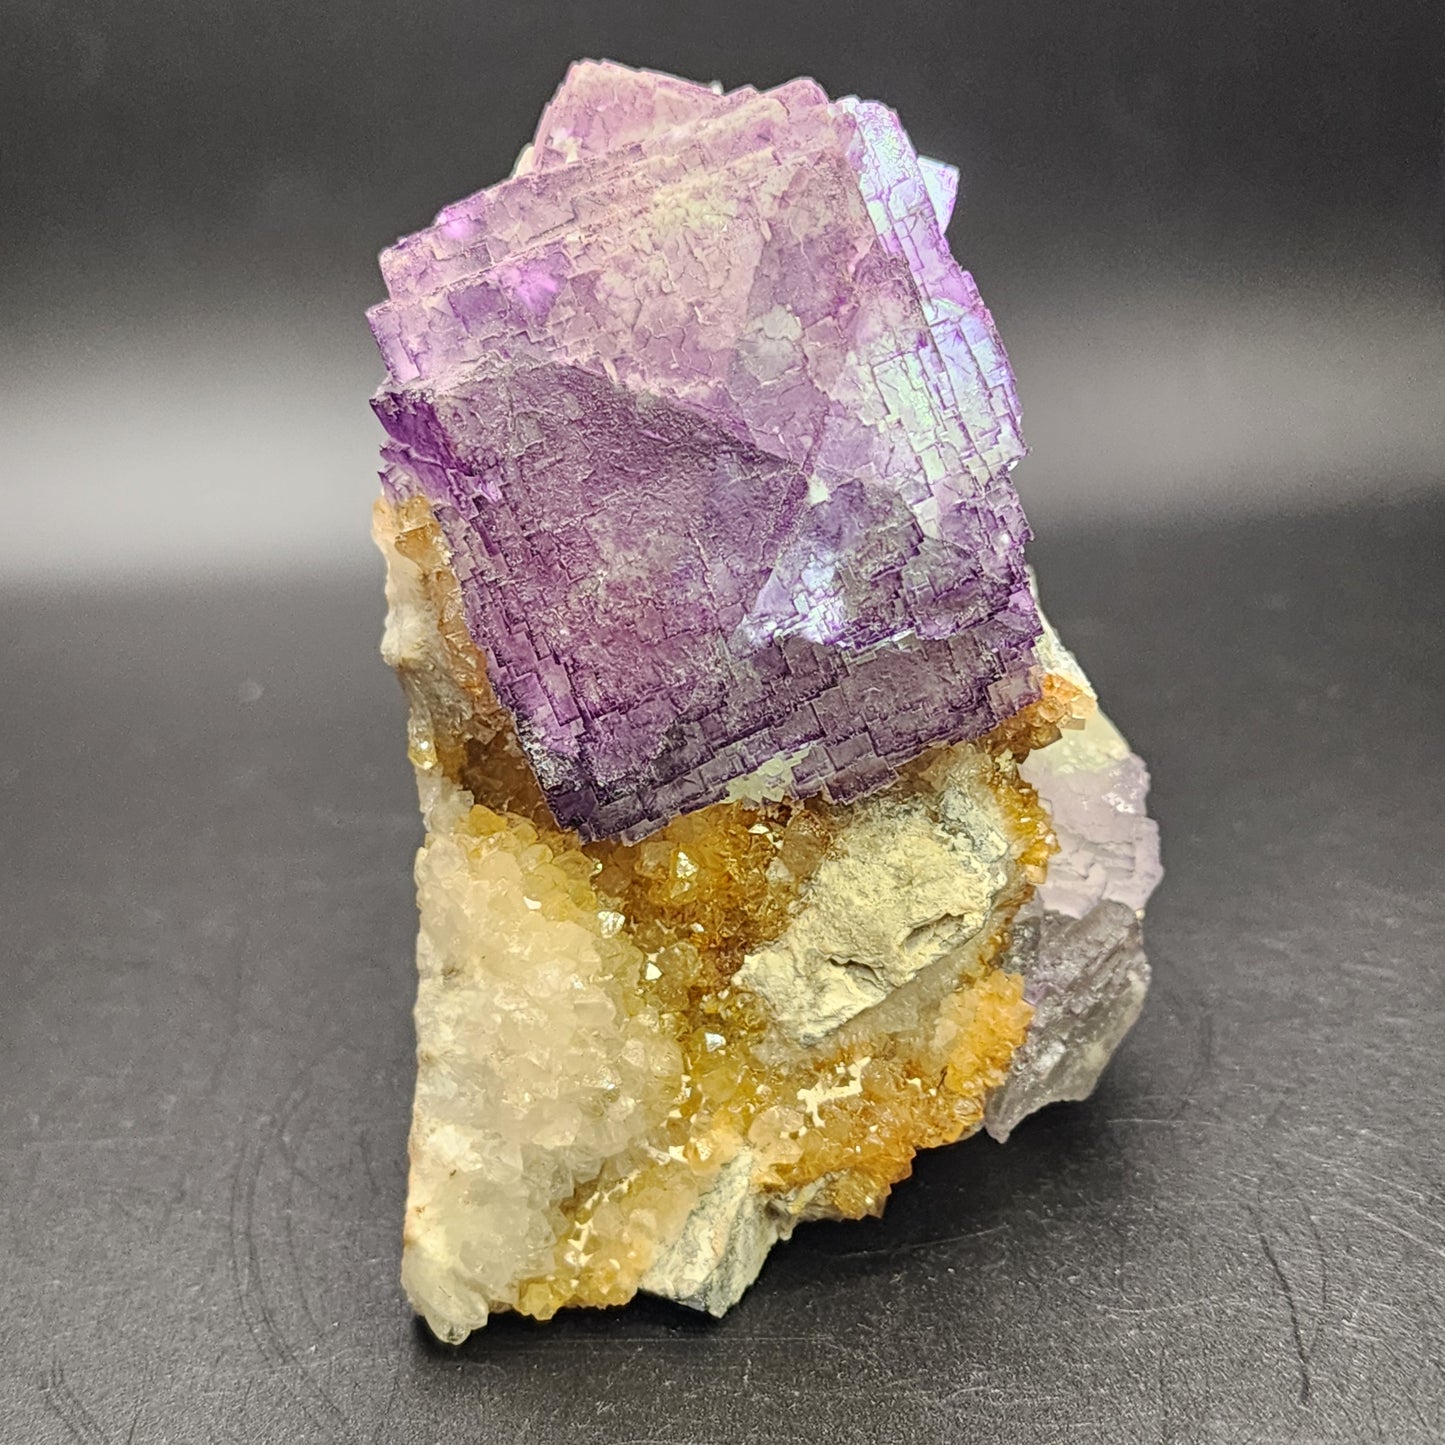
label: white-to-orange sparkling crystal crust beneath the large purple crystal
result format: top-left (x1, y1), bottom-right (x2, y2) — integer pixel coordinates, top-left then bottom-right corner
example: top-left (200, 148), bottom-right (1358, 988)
top-left (374, 499), bottom-right (1094, 1340)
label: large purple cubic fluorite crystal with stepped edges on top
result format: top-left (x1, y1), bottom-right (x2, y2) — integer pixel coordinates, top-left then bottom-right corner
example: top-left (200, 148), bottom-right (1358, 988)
top-left (370, 64), bottom-right (1039, 838)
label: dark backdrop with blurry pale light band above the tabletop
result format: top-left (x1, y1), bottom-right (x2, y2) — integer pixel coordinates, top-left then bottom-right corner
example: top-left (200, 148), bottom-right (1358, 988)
top-left (0, 0), bottom-right (1445, 577)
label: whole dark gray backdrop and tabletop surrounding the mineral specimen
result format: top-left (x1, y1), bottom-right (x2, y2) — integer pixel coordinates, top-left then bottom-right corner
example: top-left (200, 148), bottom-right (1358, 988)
top-left (0, 0), bottom-right (1445, 1445)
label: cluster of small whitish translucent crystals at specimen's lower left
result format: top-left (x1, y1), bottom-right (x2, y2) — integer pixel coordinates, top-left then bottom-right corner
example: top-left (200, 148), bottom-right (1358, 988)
top-left (405, 786), bottom-right (682, 1338)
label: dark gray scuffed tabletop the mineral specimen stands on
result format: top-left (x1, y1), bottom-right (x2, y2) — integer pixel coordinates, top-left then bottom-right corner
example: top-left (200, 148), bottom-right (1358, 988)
top-left (0, 497), bottom-right (1445, 1445)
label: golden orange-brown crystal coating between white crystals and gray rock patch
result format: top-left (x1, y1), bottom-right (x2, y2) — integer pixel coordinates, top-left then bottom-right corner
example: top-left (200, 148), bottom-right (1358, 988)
top-left (376, 499), bottom-right (1069, 1318)
